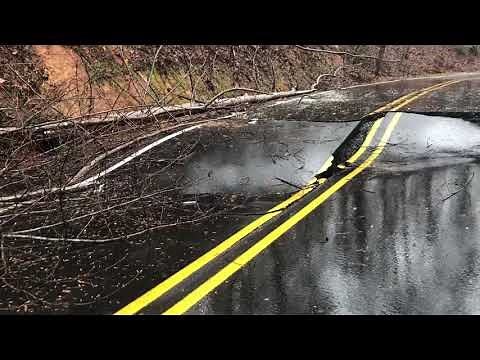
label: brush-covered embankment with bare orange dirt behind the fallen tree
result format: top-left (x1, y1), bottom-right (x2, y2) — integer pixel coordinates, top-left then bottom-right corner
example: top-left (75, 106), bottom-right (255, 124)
top-left (0, 45), bottom-right (480, 126)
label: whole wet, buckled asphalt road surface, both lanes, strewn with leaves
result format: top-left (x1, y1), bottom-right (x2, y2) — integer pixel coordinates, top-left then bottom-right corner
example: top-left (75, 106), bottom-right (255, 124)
top-left (11, 74), bottom-right (480, 314)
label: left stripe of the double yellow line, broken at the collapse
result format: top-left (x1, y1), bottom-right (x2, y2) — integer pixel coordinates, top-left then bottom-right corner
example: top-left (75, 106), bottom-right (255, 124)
top-left (114, 79), bottom-right (462, 315)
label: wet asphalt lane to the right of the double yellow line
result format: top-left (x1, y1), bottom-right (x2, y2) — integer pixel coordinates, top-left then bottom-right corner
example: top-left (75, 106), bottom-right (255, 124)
top-left (171, 76), bottom-right (480, 314)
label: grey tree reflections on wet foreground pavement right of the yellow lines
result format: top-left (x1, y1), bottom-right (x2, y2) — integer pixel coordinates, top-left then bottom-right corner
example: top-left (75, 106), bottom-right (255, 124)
top-left (191, 163), bottom-right (480, 314)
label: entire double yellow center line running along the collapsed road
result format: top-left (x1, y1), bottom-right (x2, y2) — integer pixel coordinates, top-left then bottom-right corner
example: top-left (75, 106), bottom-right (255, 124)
top-left (115, 80), bottom-right (459, 315)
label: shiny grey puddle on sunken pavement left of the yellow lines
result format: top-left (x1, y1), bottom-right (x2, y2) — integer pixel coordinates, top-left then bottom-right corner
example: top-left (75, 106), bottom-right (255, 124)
top-left (185, 121), bottom-right (358, 194)
